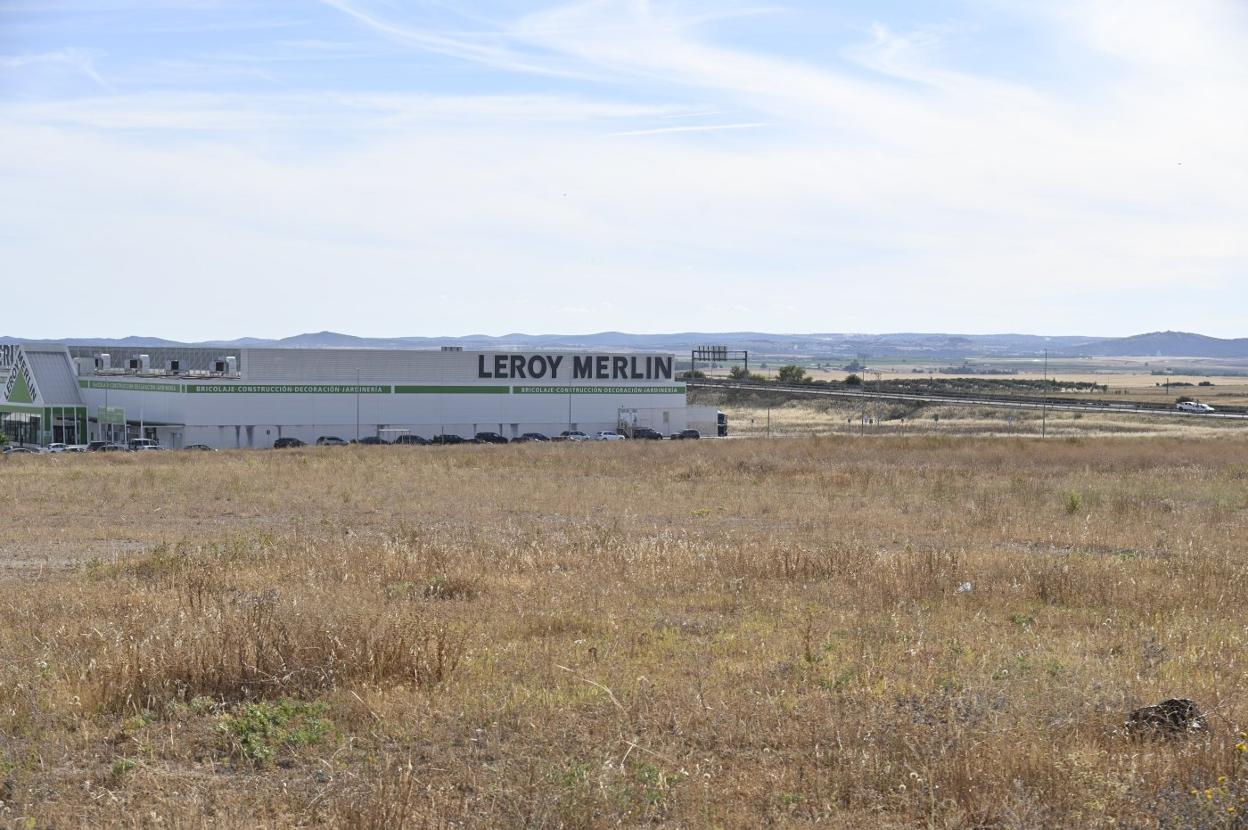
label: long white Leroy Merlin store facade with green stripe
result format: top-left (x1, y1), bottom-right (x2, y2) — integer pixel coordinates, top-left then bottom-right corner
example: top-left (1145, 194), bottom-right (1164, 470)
top-left (2, 344), bottom-right (716, 449)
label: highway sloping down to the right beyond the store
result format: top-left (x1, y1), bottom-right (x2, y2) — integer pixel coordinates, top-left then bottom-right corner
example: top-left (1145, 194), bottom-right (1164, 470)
top-left (685, 378), bottom-right (1248, 421)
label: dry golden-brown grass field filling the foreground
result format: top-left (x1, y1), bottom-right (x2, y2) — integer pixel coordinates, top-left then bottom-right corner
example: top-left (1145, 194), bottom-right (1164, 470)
top-left (0, 434), bottom-right (1248, 829)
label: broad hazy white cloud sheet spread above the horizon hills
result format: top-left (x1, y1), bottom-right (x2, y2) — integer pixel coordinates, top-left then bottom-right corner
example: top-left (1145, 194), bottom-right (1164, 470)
top-left (0, 0), bottom-right (1248, 337)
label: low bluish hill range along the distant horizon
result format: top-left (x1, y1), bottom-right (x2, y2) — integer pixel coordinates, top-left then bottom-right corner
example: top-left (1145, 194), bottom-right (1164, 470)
top-left (0, 331), bottom-right (1248, 361)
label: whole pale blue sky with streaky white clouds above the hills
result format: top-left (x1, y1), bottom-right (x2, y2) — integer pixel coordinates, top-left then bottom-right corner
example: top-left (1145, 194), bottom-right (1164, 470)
top-left (0, 0), bottom-right (1248, 341)
